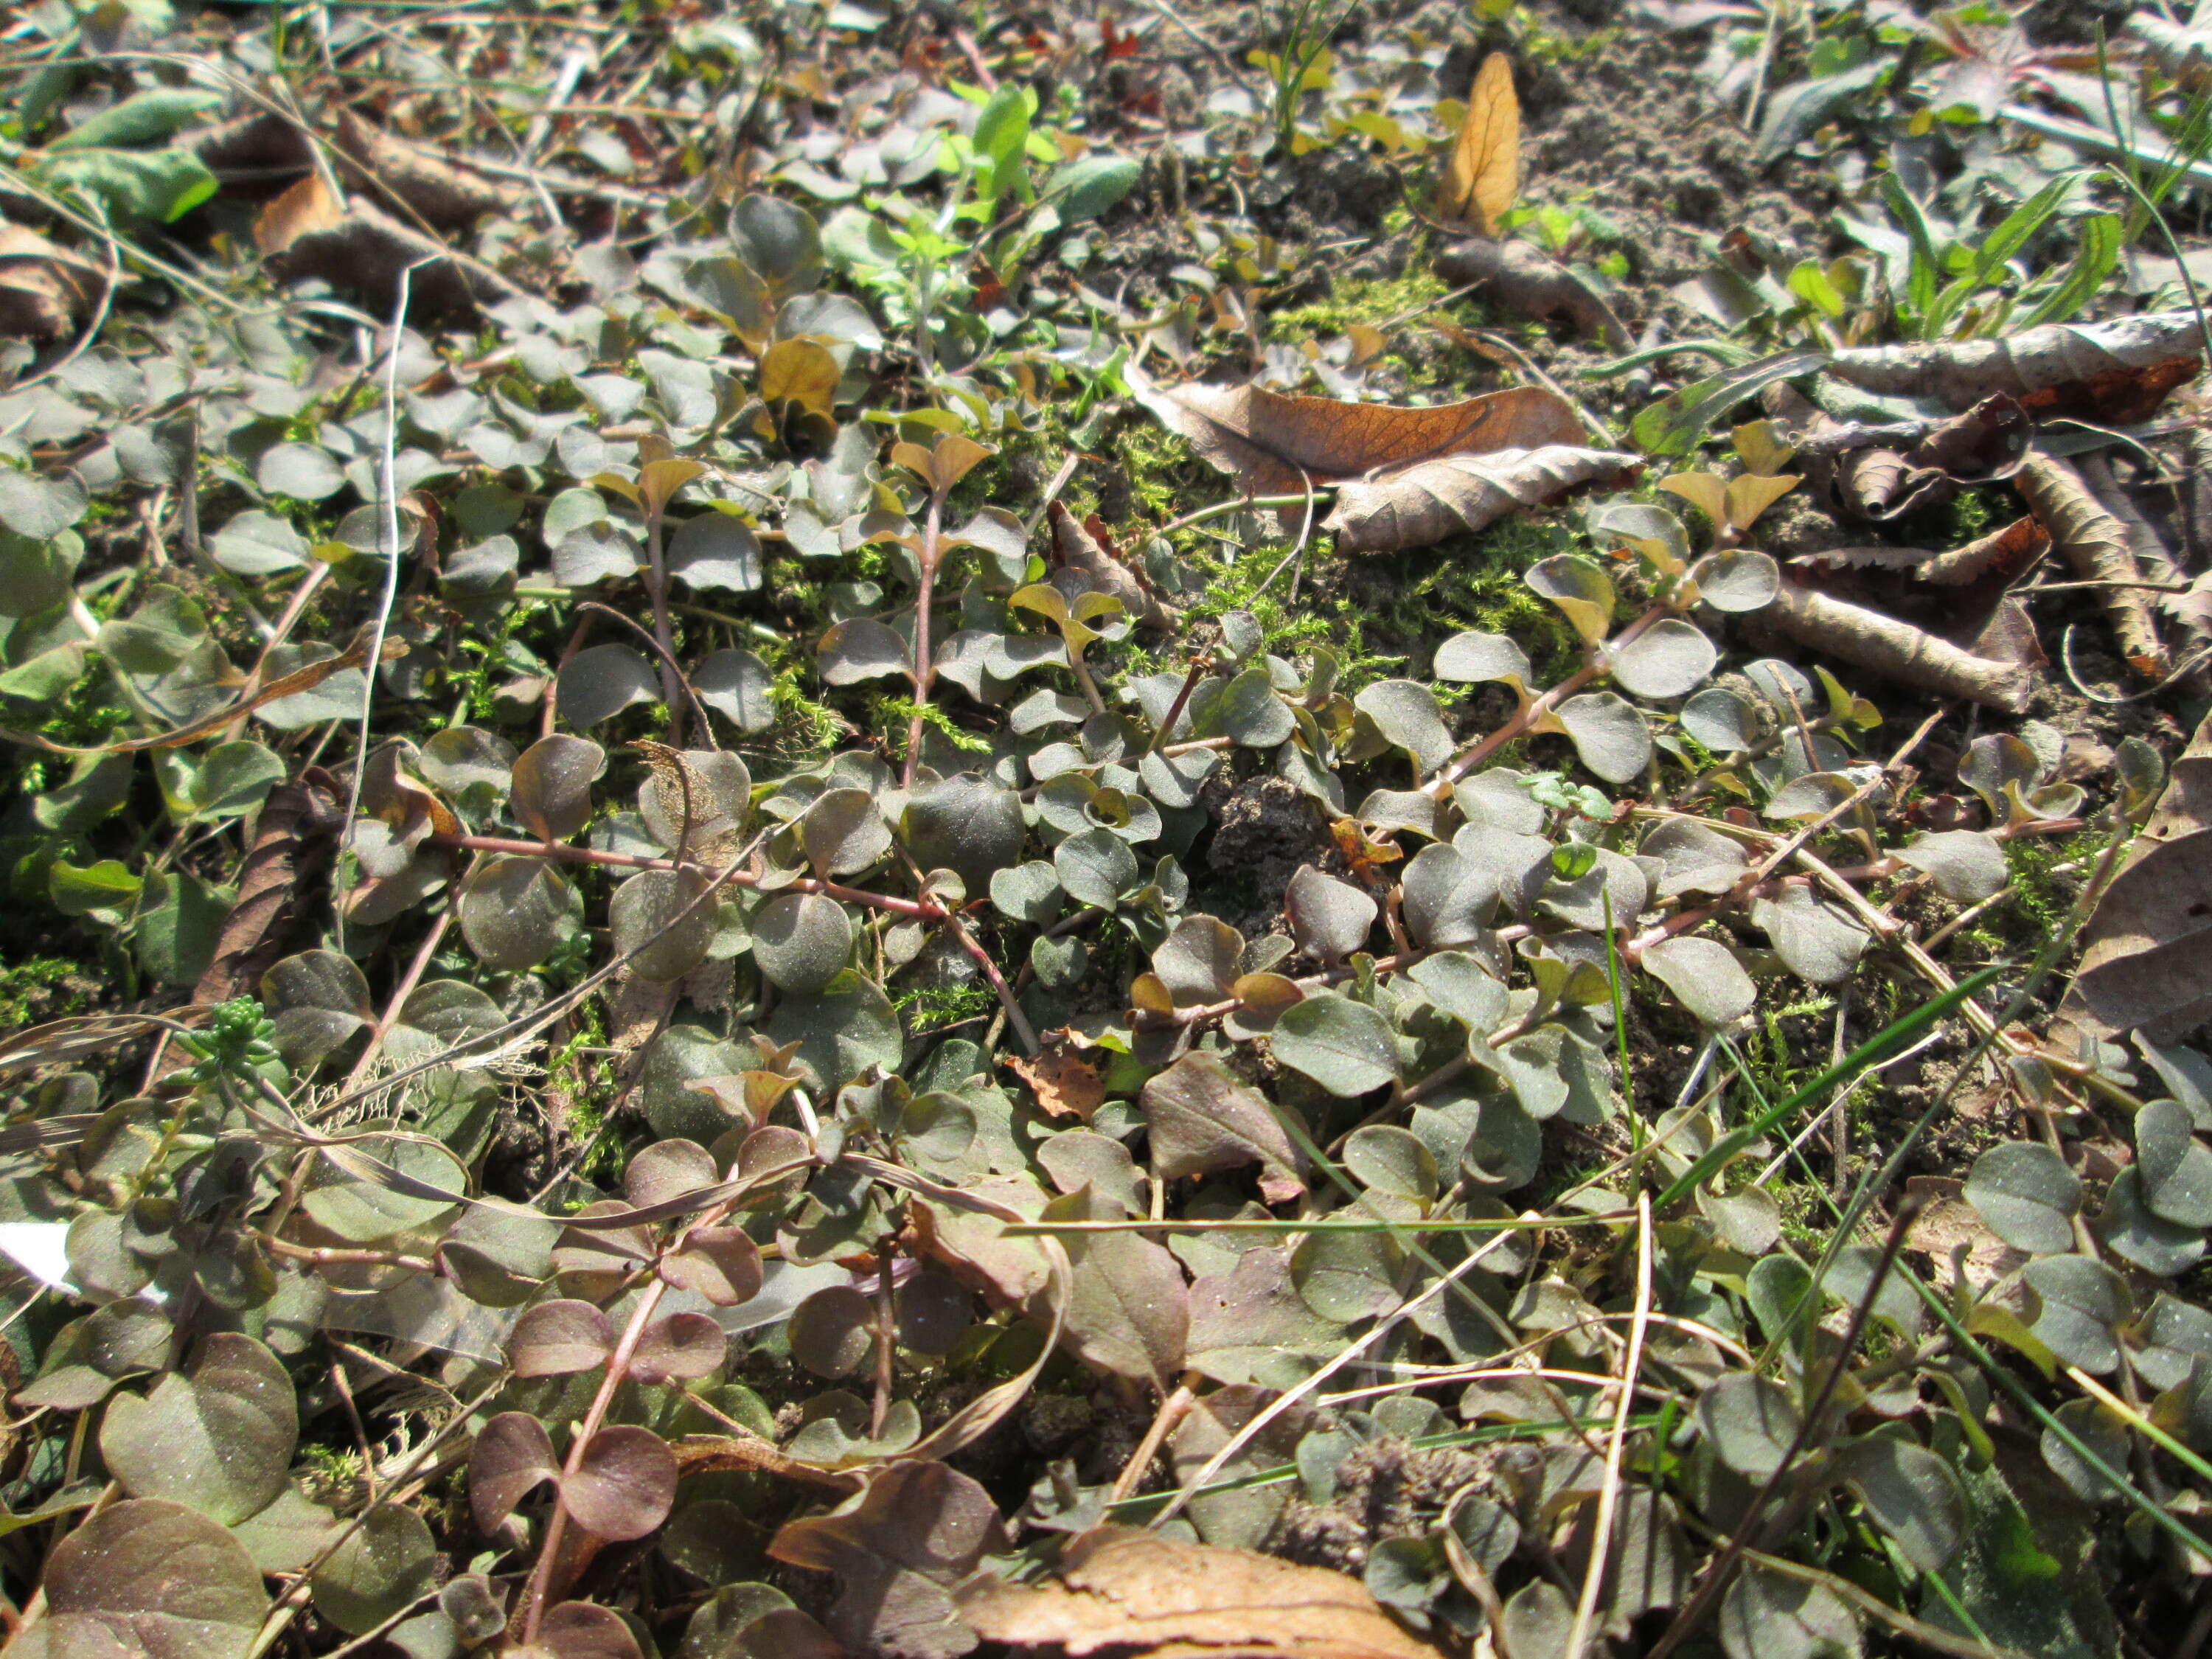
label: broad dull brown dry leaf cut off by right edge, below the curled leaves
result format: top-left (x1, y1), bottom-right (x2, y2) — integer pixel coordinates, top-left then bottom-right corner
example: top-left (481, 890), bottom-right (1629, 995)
top-left (2057, 714), bottom-right (2212, 1042)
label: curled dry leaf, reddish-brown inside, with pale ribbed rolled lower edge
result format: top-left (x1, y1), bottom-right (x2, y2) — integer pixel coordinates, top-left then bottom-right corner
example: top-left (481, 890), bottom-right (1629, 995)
top-left (1124, 367), bottom-right (1639, 551)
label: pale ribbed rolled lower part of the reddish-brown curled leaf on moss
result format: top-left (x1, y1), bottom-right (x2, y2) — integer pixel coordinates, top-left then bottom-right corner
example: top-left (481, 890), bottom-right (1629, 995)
top-left (1323, 445), bottom-right (1641, 553)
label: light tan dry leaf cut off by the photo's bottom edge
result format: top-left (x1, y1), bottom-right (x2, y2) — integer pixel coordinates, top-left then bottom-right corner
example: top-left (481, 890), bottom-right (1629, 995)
top-left (956, 1526), bottom-right (1438, 1659)
